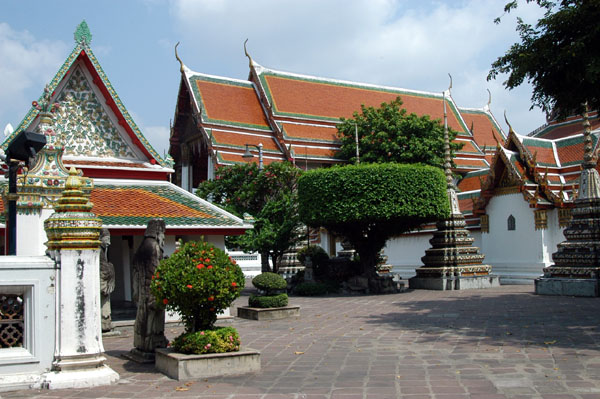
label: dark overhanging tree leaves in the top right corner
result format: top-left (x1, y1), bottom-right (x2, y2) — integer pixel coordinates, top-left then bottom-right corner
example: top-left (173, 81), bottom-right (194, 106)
top-left (488, 0), bottom-right (600, 117)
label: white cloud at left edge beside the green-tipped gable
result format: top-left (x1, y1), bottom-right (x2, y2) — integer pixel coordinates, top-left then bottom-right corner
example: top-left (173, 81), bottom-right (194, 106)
top-left (0, 22), bottom-right (68, 134)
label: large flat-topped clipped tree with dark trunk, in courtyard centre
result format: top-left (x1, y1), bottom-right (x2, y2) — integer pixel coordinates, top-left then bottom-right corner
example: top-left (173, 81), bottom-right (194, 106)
top-left (298, 163), bottom-right (450, 275)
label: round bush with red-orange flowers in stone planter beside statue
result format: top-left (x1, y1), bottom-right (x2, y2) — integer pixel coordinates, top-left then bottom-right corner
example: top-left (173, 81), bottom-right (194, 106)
top-left (150, 241), bottom-right (260, 379)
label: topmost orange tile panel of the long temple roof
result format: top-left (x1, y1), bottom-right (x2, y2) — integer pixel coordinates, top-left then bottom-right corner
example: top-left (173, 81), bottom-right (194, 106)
top-left (261, 73), bottom-right (465, 132)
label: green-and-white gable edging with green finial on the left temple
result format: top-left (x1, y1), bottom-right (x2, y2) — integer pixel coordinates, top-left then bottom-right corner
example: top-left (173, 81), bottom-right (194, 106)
top-left (0, 21), bottom-right (172, 168)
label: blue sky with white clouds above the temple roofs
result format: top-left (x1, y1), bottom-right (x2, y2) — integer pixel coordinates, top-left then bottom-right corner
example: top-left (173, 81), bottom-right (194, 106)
top-left (0, 0), bottom-right (545, 159)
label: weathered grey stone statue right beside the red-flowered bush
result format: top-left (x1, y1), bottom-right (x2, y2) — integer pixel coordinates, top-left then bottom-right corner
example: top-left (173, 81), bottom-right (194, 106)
top-left (132, 219), bottom-right (168, 361)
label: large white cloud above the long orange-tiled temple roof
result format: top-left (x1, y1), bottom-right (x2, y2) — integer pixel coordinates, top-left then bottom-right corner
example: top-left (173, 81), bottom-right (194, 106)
top-left (171, 0), bottom-right (544, 134)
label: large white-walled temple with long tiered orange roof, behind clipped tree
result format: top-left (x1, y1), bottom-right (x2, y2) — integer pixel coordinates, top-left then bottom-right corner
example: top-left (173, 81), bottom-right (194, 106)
top-left (169, 47), bottom-right (600, 279)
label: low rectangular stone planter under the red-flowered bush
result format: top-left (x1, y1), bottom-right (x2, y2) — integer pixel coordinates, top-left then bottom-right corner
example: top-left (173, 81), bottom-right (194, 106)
top-left (154, 348), bottom-right (260, 381)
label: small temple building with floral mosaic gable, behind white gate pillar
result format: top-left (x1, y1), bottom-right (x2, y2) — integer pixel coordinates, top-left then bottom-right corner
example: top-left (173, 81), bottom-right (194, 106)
top-left (1, 21), bottom-right (251, 303)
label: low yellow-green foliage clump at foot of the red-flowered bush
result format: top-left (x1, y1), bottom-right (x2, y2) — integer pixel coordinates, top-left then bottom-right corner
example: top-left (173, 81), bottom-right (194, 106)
top-left (171, 327), bottom-right (240, 355)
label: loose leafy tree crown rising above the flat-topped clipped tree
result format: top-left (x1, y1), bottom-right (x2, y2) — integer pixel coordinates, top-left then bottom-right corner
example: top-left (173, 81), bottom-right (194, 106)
top-left (336, 97), bottom-right (462, 167)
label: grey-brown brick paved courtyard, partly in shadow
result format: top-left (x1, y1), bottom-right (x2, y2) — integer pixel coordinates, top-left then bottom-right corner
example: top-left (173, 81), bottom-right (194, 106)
top-left (0, 285), bottom-right (600, 399)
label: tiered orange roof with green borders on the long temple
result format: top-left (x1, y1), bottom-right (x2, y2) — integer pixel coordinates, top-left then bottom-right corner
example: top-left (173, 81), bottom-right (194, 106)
top-left (170, 52), bottom-right (505, 173)
